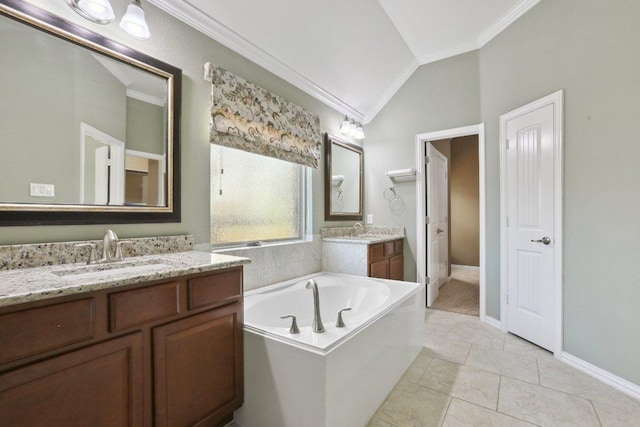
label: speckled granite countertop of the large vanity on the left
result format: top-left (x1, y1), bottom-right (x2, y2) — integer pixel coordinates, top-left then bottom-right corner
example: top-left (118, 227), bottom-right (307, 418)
top-left (0, 251), bottom-right (251, 307)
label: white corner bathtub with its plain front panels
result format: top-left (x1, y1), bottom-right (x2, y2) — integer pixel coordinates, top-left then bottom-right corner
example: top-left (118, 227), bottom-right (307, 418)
top-left (235, 273), bottom-right (425, 427)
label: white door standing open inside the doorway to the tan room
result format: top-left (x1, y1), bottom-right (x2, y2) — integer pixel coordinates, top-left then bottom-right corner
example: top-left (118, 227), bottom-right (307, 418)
top-left (426, 143), bottom-right (449, 306)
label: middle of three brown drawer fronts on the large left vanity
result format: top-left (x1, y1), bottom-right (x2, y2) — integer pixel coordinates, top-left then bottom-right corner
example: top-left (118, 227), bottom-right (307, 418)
top-left (109, 282), bottom-right (180, 332)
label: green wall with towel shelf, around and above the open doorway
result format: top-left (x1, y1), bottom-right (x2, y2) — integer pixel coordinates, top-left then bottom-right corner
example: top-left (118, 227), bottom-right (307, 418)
top-left (364, 51), bottom-right (480, 280)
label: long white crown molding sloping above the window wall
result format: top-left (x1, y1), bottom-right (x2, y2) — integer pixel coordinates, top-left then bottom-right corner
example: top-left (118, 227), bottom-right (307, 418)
top-left (147, 0), bottom-right (364, 122)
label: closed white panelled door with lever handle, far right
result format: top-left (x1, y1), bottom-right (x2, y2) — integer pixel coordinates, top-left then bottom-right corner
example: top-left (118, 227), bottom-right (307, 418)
top-left (506, 104), bottom-right (559, 351)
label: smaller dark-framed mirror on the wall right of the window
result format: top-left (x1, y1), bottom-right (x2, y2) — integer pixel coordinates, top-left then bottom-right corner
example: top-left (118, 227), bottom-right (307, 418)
top-left (324, 133), bottom-right (364, 221)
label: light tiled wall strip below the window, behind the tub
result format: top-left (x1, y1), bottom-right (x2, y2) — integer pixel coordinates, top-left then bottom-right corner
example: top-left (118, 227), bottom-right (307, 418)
top-left (194, 234), bottom-right (322, 291)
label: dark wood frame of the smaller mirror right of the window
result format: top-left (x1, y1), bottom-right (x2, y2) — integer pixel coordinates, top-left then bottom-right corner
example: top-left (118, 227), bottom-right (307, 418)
top-left (324, 133), bottom-right (364, 221)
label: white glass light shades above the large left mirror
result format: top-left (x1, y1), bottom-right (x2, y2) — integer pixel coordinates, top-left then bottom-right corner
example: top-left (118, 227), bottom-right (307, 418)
top-left (66, 0), bottom-right (151, 40)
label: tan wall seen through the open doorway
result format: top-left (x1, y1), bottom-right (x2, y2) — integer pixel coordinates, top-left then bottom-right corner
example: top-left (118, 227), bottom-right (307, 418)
top-left (449, 135), bottom-right (480, 266)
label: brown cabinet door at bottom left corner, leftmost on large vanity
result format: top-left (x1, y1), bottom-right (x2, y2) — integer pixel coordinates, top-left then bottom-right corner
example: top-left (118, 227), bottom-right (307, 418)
top-left (0, 334), bottom-right (143, 427)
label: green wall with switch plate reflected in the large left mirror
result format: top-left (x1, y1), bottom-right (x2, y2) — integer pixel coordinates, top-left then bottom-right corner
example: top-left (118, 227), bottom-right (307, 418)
top-left (0, 22), bottom-right (126, 204)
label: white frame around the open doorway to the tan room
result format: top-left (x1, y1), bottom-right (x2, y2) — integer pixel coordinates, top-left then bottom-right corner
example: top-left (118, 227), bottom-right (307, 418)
top-left (416, 123), bottom-right (487, 322)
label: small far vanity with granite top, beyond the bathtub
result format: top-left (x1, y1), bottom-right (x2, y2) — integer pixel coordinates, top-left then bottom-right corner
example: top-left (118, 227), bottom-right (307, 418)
top-left (322, 227), bottom-right (404, 280)
